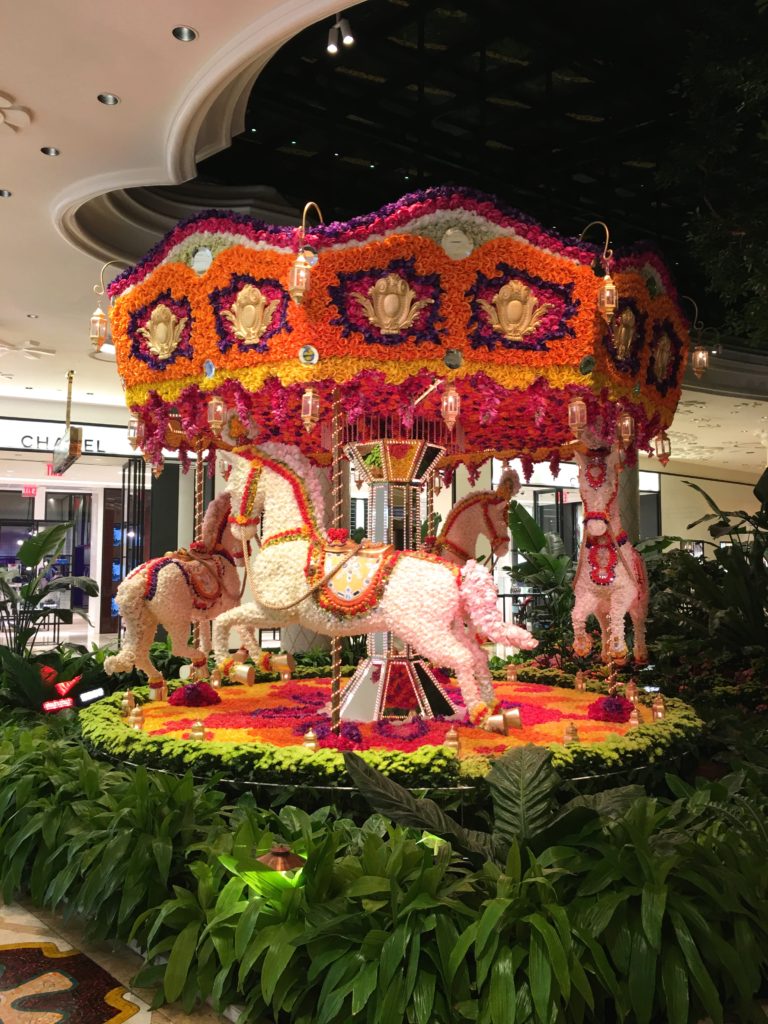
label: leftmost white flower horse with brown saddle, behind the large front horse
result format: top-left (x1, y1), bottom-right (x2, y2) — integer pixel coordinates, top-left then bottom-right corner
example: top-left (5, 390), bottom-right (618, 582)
top-left (104, 494), bottom-right (243, 678)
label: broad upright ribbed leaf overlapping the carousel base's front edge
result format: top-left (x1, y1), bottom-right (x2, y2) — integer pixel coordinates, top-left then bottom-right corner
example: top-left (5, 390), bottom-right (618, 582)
top-left (487, 743), bottom-right (560, 849)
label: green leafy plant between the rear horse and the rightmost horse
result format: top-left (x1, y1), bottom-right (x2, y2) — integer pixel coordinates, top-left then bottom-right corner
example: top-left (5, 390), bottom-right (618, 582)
top-left (505, 501), bottom-right (575, 664)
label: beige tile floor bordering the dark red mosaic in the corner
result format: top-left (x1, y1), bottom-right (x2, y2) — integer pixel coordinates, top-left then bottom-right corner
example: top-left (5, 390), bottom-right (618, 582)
top-left (0, 901), bottom-right (228, 1024)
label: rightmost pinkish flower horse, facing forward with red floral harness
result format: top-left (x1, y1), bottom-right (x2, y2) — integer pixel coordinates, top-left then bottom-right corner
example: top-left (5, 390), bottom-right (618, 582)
top-left (571, 449), bottom-right (648, 664)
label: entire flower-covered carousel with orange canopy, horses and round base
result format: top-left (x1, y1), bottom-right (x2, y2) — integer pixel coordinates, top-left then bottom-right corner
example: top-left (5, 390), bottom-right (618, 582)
top-left (83, 188), bottom-right (696, 785)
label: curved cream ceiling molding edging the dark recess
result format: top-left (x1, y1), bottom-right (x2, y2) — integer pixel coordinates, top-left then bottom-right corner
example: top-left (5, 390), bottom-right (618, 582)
top-left (51, 0), bottom-right (351, 262)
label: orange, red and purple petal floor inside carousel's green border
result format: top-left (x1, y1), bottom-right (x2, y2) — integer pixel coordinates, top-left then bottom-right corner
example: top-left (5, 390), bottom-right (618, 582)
top-left (143, 679), bottom-right (649, 754)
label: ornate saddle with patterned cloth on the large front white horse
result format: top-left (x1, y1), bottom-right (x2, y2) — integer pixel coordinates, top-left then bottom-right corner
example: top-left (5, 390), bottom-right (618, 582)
top-left (307, 544), bottom-right (397, 615)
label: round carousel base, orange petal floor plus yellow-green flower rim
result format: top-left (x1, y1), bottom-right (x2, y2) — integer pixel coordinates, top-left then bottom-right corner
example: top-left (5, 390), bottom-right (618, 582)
top-left (80, 678), bottom-right (703, 788)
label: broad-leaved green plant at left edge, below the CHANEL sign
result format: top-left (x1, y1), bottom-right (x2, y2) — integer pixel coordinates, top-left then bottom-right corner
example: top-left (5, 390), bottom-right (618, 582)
top-left (0, 522), bottom-right (98, 656)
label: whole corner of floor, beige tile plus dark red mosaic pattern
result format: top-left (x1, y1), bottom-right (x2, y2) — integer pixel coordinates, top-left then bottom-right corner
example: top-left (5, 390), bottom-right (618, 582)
top-left (0, 903), bottom-right (222, 1024)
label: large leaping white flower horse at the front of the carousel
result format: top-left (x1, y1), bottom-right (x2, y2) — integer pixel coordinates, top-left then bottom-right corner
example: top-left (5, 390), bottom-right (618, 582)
top-left (213, 442), bottom-right (537, 723)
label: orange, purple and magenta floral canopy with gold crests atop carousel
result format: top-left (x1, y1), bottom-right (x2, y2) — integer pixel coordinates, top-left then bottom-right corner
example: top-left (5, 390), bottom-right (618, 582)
top-left (109, 188), bottom-right (688, 467)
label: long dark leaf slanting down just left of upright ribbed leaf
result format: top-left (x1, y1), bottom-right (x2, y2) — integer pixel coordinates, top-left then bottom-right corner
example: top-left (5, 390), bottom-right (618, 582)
top-left (344, 751), bottom-right (494, 860)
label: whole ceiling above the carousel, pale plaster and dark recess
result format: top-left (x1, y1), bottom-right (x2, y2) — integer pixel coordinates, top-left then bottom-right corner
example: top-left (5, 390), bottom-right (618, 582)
top-left (0, 0), bottom-right (768, 472)
